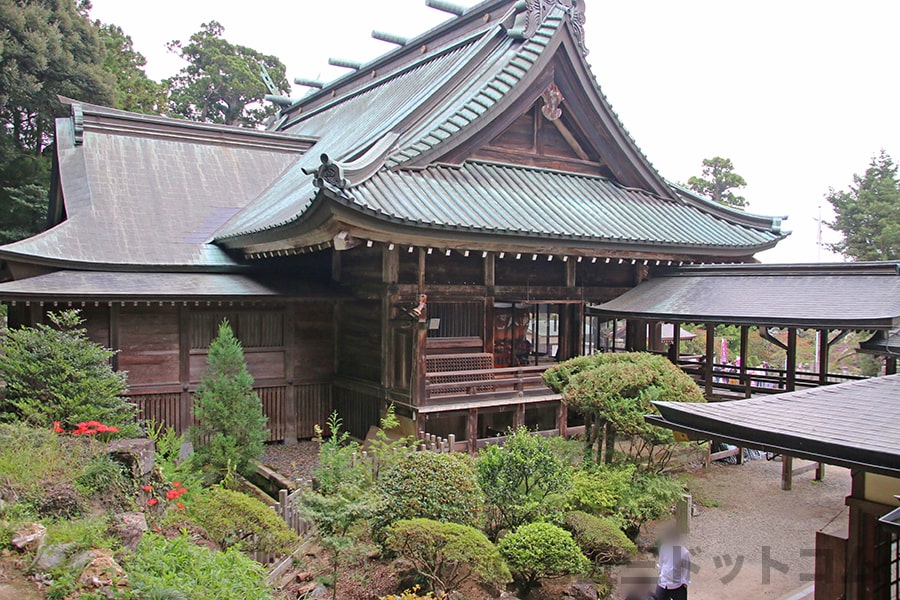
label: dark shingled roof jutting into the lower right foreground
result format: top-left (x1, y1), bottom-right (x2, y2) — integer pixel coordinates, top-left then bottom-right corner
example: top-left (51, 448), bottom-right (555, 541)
top-left (646, 375), bottom-right (900, 477)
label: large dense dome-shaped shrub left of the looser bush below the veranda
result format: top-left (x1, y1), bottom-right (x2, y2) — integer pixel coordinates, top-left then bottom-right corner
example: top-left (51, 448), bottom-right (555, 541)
top-left (380, 452), bottom-right (483, 525)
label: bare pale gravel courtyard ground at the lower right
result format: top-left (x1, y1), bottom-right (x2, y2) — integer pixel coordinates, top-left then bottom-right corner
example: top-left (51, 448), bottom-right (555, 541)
top-left (612, 460), bottom-right (850, 600)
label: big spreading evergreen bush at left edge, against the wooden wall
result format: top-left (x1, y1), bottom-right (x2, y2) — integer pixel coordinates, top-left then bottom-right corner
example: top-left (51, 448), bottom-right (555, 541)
top-left (0, 310), bottom-right (139, 436)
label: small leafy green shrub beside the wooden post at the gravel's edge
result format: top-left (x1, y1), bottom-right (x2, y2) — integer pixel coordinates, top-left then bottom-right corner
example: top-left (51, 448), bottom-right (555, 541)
top-left (612, 472), bottom-right (684, 540)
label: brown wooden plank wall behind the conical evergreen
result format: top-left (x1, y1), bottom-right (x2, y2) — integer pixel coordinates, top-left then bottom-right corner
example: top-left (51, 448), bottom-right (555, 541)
top-left (63, 303), bottom-right (335, 441)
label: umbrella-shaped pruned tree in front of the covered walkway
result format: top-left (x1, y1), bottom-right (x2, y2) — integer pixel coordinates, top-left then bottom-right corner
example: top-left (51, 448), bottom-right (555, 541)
top-left (544, 352), bottom-right (704, 471)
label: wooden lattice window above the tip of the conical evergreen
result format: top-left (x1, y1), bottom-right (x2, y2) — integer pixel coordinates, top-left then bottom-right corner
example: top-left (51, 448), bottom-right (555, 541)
top-left (191, 309), bottom-right (284, 350)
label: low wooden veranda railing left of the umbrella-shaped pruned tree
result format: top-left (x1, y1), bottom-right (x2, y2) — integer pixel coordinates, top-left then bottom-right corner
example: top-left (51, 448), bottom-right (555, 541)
top-left (425, 365), bottom-right (548, 402)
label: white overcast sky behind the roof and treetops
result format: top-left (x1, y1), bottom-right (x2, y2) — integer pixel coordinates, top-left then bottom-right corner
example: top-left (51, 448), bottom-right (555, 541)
top-left (86, 0), bottom-right (900, 262)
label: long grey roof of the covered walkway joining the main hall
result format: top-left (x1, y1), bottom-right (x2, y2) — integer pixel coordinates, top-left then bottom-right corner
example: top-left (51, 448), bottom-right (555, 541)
top-left (592, 262), bottom-right (900, 330)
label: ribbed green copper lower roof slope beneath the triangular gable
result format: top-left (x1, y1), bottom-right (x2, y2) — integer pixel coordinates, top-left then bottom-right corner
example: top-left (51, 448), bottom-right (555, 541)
top-left (351, 162), bottom-right (782, 250)
